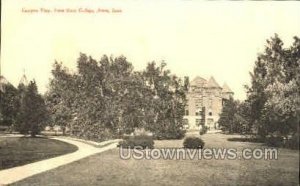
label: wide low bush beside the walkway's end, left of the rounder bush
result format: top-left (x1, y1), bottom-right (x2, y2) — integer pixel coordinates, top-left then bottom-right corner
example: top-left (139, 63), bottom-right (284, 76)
top-left (118, 135), bottom-right (154, 149)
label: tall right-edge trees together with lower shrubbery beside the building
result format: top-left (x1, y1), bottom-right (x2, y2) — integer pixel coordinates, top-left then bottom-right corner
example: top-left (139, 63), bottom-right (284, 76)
top-left (219, 35), bottom-right (300, 141)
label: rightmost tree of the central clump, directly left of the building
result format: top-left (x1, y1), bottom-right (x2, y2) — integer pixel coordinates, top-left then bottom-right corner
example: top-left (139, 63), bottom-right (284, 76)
top-left (143, 62), bottom-right (188, 139)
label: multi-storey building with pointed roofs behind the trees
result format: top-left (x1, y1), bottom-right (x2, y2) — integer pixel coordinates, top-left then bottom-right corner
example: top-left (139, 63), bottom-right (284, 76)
top-left (184, 76), bottom-right (233, 130)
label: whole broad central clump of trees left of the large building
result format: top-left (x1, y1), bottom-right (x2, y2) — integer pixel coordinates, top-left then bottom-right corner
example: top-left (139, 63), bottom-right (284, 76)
top-left (46, 54), bottom-right (187, 140)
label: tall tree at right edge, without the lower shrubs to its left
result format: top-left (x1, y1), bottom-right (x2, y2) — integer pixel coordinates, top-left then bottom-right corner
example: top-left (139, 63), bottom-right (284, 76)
top-left (246, 35), bottom-right (300, 137)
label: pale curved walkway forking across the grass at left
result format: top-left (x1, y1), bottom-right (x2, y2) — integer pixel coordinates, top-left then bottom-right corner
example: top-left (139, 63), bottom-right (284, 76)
top-left (0, 138), bottom-right (117, 185)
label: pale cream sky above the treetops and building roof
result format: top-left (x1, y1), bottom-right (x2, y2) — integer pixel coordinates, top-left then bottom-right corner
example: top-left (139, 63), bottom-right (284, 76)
top-left (1, 0), bottom-right (300, 100)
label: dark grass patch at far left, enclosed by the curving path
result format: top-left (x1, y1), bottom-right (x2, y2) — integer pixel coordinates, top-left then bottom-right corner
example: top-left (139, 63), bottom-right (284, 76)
top-left (0, 137), bottom-right (77, 170)
